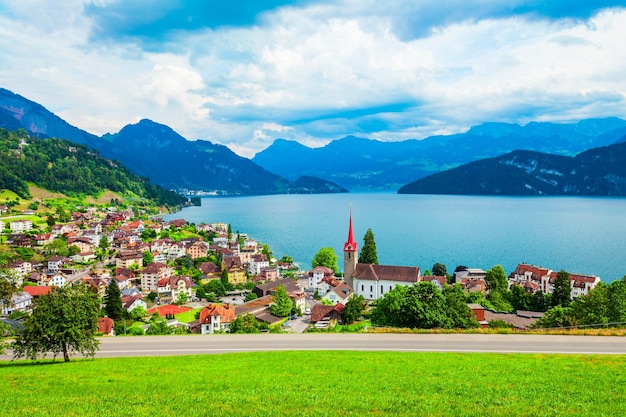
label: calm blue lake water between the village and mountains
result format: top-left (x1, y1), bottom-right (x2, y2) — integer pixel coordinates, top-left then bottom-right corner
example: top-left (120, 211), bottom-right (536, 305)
top-left (166, 193), bottom-right (626, 282)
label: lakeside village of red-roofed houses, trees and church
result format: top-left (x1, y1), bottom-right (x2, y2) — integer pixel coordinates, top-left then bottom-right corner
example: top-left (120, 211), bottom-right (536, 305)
top-left (0, 200), bottom-right (600, 335)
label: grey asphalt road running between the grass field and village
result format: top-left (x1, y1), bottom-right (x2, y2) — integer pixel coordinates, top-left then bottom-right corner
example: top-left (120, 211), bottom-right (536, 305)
top-left (0, 333), bottom-right (626, 360)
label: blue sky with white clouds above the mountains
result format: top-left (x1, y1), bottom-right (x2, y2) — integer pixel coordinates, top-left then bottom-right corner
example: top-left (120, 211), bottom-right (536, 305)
top-left (0, 0), bottom-right (626, 157)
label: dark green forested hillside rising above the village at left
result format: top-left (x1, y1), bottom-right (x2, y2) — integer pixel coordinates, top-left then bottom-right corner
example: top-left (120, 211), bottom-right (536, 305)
top-left (0, 129), bottom-right (186, 206)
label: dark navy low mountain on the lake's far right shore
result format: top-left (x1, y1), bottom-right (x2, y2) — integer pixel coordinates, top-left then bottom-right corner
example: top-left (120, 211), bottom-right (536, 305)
top-left (398, 142), bottom-right (626, 196)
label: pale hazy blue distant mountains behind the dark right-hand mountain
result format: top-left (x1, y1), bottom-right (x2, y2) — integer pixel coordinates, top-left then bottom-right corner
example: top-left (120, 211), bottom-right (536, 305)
top-left (252, 118), bottom-right (626, 190)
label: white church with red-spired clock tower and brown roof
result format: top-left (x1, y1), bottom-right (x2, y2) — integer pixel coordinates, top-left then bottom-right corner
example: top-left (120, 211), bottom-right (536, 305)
top-left (343, 210), bottom-right (422, 300)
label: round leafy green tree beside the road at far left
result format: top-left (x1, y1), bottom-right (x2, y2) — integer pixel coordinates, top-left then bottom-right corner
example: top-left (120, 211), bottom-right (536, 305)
top-left (12, 285), bottom-right (100, 362)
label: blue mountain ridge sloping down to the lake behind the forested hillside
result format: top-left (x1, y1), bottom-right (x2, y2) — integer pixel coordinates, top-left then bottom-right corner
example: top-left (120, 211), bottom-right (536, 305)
top-left (0, 88), bottom-right (347, 195)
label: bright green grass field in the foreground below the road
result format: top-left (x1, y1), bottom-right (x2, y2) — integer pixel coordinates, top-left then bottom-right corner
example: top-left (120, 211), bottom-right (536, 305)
top-left (0, 351), bottom-right (626, 417)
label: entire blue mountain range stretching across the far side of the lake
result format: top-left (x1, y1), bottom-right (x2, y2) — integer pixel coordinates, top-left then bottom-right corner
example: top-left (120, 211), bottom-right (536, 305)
top-left (0, 88), bottom-right (626, 195)
